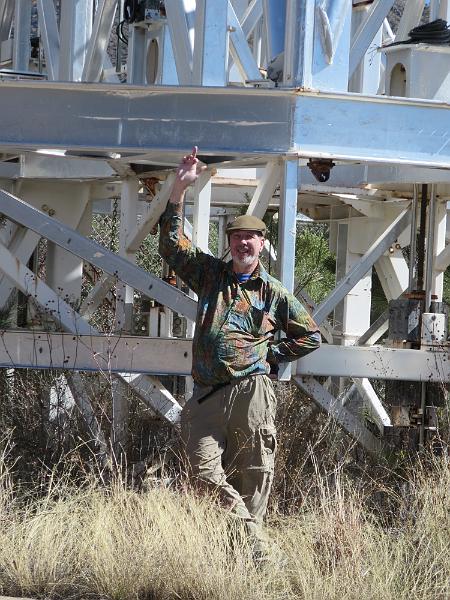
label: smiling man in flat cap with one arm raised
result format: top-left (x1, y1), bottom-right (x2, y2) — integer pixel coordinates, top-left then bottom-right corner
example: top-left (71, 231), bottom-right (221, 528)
top-left (159, 148), bottom-right (320, 556)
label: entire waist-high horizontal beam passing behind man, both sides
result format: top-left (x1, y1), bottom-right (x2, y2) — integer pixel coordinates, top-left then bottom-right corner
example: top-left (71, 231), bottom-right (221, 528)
top-left (0, 330), bottom-right (450, 382)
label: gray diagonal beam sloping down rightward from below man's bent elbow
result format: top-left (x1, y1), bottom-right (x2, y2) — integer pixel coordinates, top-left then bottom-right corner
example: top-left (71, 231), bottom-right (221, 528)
top-left (293, 377), bottom-right (382, 453)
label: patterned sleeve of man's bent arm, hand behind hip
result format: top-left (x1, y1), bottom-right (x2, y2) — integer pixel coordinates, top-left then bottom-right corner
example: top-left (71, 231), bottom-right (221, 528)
top-left (267, 290), bottom-right (321, 364)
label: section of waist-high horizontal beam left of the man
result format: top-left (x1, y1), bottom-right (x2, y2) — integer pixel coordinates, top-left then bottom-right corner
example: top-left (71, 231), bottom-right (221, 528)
top-left (0, 330), bottom-right (192, 375)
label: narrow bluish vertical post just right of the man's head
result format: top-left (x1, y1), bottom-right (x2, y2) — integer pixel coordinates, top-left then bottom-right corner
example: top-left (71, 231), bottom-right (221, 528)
top-left (277, 157), bottom-right (299, 381)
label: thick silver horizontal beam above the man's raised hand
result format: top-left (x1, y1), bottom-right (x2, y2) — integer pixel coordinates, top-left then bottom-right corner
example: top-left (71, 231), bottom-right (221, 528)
top-left (0, 81), bottom-right (450, 168)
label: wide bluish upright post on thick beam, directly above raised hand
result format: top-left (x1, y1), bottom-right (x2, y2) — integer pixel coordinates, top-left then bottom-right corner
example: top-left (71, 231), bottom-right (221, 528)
top-left (193, 0), bottom-right (229, 86)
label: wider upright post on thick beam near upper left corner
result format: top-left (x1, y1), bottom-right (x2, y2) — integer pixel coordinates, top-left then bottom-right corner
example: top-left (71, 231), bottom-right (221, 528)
top-left (59, 0), bottom-right (93, 81)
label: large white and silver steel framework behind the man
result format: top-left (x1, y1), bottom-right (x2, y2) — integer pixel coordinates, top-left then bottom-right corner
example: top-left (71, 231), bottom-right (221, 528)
top-left (0, 0), bottom-right (450, 450)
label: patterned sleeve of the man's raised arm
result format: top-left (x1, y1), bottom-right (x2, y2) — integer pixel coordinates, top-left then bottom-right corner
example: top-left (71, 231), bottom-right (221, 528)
top-left (159, 202), bottom-right (216, 293)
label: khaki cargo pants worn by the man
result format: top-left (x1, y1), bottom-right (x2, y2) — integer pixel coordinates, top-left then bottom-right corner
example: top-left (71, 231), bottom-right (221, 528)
top-left (181, 375), bottom-right (277, 538)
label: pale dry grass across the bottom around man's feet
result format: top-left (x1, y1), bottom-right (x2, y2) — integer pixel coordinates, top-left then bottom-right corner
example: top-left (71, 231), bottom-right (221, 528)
top-left (0, 450), bottom-right (450, 600)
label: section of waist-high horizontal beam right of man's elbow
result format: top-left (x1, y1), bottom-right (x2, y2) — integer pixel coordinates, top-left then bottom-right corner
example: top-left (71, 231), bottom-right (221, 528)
top-left (296, 344), bottom-right (450, 383)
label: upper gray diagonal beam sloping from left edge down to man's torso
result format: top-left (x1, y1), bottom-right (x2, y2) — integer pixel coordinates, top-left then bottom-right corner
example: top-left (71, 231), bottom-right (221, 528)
top-left (0, 190), bottom-right (196, 319)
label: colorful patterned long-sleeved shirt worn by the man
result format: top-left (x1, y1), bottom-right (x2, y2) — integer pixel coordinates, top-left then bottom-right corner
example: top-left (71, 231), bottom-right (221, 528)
top-left (159, 202), bottom-right (321, 386)
